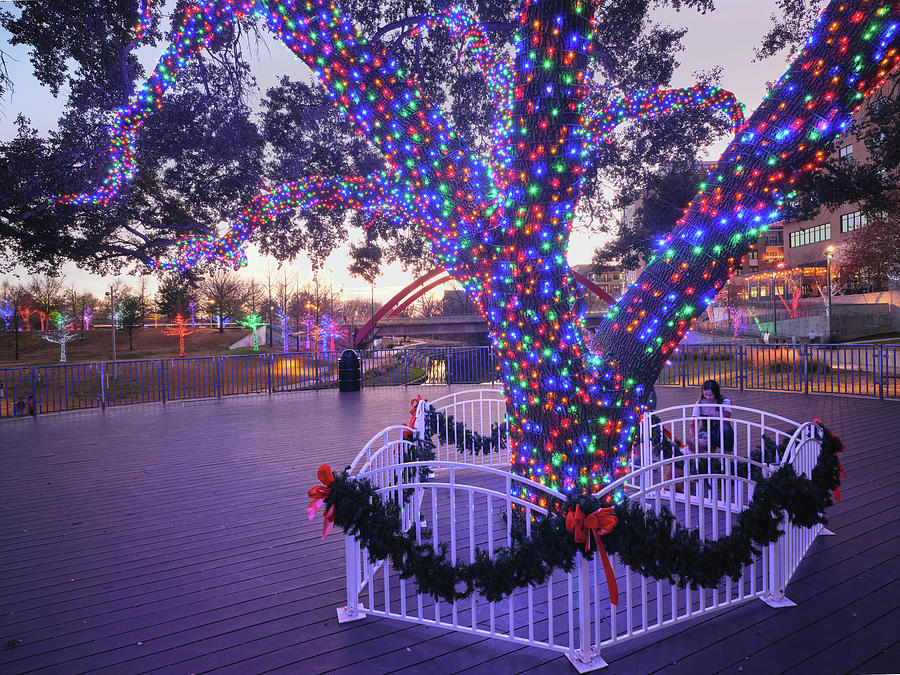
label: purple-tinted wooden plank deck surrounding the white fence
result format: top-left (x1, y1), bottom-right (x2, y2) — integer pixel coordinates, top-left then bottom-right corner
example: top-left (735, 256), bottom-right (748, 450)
top-left (0, 387), bottom-right (900, 675)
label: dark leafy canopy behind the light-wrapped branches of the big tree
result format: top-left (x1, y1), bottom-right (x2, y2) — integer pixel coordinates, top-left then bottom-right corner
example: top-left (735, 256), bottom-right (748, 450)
top-left (0, 0), bottom-right (740, 280)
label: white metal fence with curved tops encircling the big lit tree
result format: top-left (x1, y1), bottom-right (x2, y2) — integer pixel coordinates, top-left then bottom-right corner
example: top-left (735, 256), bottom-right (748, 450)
top-left (339, 390), bottom-right (822, 670)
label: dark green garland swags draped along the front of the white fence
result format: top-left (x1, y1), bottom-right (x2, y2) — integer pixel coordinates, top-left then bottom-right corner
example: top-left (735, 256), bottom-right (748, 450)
top-left (325, 429), bottom-right (843, 602)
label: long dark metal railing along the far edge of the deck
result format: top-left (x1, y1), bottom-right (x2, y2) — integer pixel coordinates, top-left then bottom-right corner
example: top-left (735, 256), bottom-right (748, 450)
top-left (0, 343), bottom-right (900, 418)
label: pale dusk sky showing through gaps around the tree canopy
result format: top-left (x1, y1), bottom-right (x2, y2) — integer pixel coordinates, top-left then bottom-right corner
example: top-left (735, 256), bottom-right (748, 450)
top-left (0, 0), bottom-right (787, 300)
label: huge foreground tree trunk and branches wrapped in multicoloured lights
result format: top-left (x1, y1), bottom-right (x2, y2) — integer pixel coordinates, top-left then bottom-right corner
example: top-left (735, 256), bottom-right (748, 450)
top-left (49, 0), bottom-right (900, 498)
